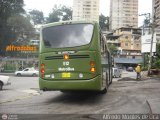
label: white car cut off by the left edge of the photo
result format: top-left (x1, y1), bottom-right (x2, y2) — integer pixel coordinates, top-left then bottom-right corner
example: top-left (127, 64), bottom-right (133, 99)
top-left (0, 75), bottom-right (11, 90)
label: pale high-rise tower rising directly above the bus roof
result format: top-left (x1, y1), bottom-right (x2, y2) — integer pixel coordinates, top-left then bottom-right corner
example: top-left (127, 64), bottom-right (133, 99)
top-left (72, 0), bottom-right (99, 21)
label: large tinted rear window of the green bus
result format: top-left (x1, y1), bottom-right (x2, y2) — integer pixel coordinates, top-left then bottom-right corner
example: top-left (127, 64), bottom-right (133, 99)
top-left (42, 24), bottom-right (93, 48)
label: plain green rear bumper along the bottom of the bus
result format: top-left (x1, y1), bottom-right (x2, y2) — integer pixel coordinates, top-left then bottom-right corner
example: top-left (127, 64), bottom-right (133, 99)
top-left (39, 75), bottom-right (102, 91)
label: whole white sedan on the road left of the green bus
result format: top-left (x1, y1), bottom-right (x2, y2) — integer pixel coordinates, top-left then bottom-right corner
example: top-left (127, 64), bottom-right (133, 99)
top-left (15, 68), bottom-right (39, 76)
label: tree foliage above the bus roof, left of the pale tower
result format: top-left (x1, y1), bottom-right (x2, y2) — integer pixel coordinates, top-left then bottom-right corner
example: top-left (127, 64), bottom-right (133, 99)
top-left (47, 5), bottom-right (72, 23)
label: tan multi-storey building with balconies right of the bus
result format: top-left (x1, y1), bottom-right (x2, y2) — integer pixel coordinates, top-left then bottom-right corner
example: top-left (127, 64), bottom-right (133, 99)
top-left (114, 27), bottom-right (141, 59)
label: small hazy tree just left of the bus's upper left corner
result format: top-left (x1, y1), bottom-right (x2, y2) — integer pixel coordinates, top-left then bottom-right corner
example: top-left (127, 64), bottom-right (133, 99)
top-left (29, 10), bottom-right (44, 25)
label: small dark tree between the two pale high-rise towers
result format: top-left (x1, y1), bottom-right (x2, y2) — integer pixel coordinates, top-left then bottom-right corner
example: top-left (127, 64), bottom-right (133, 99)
top-left (99, 14), bottom-right (109, 30)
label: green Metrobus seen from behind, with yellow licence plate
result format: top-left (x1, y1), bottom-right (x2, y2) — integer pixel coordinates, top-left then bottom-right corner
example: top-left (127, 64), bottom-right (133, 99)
top-left (39, 21), bottom-right (112, 93)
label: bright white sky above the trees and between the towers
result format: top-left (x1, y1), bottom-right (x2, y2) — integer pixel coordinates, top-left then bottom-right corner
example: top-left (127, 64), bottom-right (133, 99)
top-left (24, 0), bottom-right (152, 26)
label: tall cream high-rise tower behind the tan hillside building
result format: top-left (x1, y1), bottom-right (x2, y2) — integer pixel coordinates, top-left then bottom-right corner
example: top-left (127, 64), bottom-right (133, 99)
top-left (110, 0), bottom-right (138, 30)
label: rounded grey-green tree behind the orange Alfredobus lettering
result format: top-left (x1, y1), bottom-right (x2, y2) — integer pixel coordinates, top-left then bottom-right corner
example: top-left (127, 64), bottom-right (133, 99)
top-left (6, 14), bottom-right (34, 57)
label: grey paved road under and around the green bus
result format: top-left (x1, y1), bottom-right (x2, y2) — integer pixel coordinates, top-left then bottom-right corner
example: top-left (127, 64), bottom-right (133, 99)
top-left (0, 71), bottom-right (160, 119)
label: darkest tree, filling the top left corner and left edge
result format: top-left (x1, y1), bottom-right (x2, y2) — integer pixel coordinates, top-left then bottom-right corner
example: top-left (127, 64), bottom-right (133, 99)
top-left (0, 0), bottom-right (25, 55)
